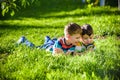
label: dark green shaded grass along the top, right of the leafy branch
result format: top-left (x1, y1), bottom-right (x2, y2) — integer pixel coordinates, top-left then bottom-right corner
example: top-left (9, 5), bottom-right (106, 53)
top-left (2, 0), bottom-right (83, 19)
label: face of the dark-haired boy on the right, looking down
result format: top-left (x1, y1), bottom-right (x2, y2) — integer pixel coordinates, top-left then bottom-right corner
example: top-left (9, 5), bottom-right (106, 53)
top-left (81, 34), bottom-right (93, 45)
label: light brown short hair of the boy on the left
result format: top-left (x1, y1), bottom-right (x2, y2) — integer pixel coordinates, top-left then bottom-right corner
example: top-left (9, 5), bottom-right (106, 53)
top-left (64, 23), bottom-right (82, 35)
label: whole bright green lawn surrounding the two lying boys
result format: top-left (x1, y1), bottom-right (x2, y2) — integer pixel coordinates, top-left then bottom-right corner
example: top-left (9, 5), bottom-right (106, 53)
top-left (0, 0), bottom-right (120, 80)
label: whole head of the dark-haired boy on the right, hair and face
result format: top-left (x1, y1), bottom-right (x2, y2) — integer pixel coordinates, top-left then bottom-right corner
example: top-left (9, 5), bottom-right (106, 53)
top-left (81, 24), bottom-right (93, 45)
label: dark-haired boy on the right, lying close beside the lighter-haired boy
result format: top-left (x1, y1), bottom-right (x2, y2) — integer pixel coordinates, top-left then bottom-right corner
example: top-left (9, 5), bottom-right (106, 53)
top-left (75, 24), bottom-right (95, 54)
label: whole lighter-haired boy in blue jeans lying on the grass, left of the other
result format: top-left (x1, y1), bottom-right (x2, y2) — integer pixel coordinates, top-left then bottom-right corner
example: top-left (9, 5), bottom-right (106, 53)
top-left (17, 23), bottom-right (82, 55)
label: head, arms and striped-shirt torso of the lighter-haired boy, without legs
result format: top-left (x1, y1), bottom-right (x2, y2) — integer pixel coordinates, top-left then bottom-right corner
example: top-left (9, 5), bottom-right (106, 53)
top-left (47, 23), bottom-right (82, 55)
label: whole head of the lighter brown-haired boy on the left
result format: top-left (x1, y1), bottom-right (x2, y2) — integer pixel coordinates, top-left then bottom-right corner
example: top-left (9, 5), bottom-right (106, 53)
top-left (64, 23), bottom-right (82, 45)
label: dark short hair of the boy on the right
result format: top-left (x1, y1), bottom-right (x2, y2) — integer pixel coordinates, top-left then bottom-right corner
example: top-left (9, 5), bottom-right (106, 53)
top-left (81, 24), bottom-right (93, 36)
